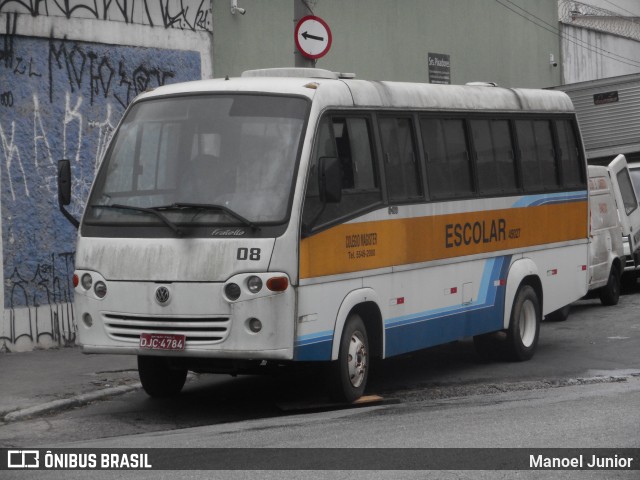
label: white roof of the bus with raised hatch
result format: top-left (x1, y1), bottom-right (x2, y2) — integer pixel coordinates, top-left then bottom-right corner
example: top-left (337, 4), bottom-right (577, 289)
top-left (139, 68), bottom-right (574, 112)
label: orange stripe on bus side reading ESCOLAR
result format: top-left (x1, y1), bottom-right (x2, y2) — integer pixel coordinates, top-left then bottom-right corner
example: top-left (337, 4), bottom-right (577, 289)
top-left (300, 201), bottom-right (588, 279)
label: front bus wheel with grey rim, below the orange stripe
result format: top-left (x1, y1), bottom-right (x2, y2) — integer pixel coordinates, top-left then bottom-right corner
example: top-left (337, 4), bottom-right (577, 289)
top-left (329, 314), bottom-right (371, 403)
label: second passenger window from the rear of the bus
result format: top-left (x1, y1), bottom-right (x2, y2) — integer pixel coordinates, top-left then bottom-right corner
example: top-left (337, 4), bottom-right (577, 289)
top-left (516, 120), bottom-right (559, 192)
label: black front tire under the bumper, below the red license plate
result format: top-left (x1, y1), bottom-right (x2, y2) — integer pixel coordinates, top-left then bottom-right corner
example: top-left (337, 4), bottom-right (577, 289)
top-left (138, 356), bottom-right (187, 398)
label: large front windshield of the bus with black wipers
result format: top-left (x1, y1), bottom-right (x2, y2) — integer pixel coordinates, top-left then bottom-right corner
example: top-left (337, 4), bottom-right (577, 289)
top-left (84, 94), bottom-right (308, 226)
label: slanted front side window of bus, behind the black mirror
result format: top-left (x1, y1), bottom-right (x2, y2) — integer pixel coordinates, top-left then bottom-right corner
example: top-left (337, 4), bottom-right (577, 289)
top-left (302, 117), bottom-right (382, 229)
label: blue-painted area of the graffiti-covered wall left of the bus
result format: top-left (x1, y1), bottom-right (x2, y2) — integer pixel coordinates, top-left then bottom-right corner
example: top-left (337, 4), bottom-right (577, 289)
top-left (0, 33), bottom-right (201, 322)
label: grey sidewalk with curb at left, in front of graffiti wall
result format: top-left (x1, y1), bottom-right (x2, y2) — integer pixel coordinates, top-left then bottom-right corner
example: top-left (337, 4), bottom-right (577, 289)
top-left (0, 347), bottom-right (141, 423)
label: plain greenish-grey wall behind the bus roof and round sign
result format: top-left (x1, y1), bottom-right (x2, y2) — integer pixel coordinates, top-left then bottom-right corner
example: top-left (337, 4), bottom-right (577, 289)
top-left (213, 0), bottom-right (561, 87)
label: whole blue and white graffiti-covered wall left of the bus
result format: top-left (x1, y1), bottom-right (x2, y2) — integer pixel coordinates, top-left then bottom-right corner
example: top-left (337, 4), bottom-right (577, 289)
top-left (0, 0), bottom-right (212, 350)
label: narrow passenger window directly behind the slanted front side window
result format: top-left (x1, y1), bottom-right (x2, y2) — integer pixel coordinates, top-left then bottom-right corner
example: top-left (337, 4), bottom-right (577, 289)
top-left (378, 118), bottom-right (422, 202)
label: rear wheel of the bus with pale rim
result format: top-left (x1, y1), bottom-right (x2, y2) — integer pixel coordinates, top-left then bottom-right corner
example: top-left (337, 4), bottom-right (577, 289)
top-left (505, 285), bottom-right (541, 362)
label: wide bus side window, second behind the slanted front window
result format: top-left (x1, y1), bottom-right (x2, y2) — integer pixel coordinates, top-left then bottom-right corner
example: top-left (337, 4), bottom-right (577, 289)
top-left (420, 118), bottom-right (474, 198)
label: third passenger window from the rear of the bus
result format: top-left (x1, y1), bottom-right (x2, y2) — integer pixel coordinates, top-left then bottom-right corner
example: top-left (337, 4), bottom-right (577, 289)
top-left (471, 120), bottom-right (518, 194)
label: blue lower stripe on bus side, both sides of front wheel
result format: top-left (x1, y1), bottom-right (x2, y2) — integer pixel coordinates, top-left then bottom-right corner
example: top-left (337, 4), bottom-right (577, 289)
top-left (294, 255), bottom-right (511, 361)
